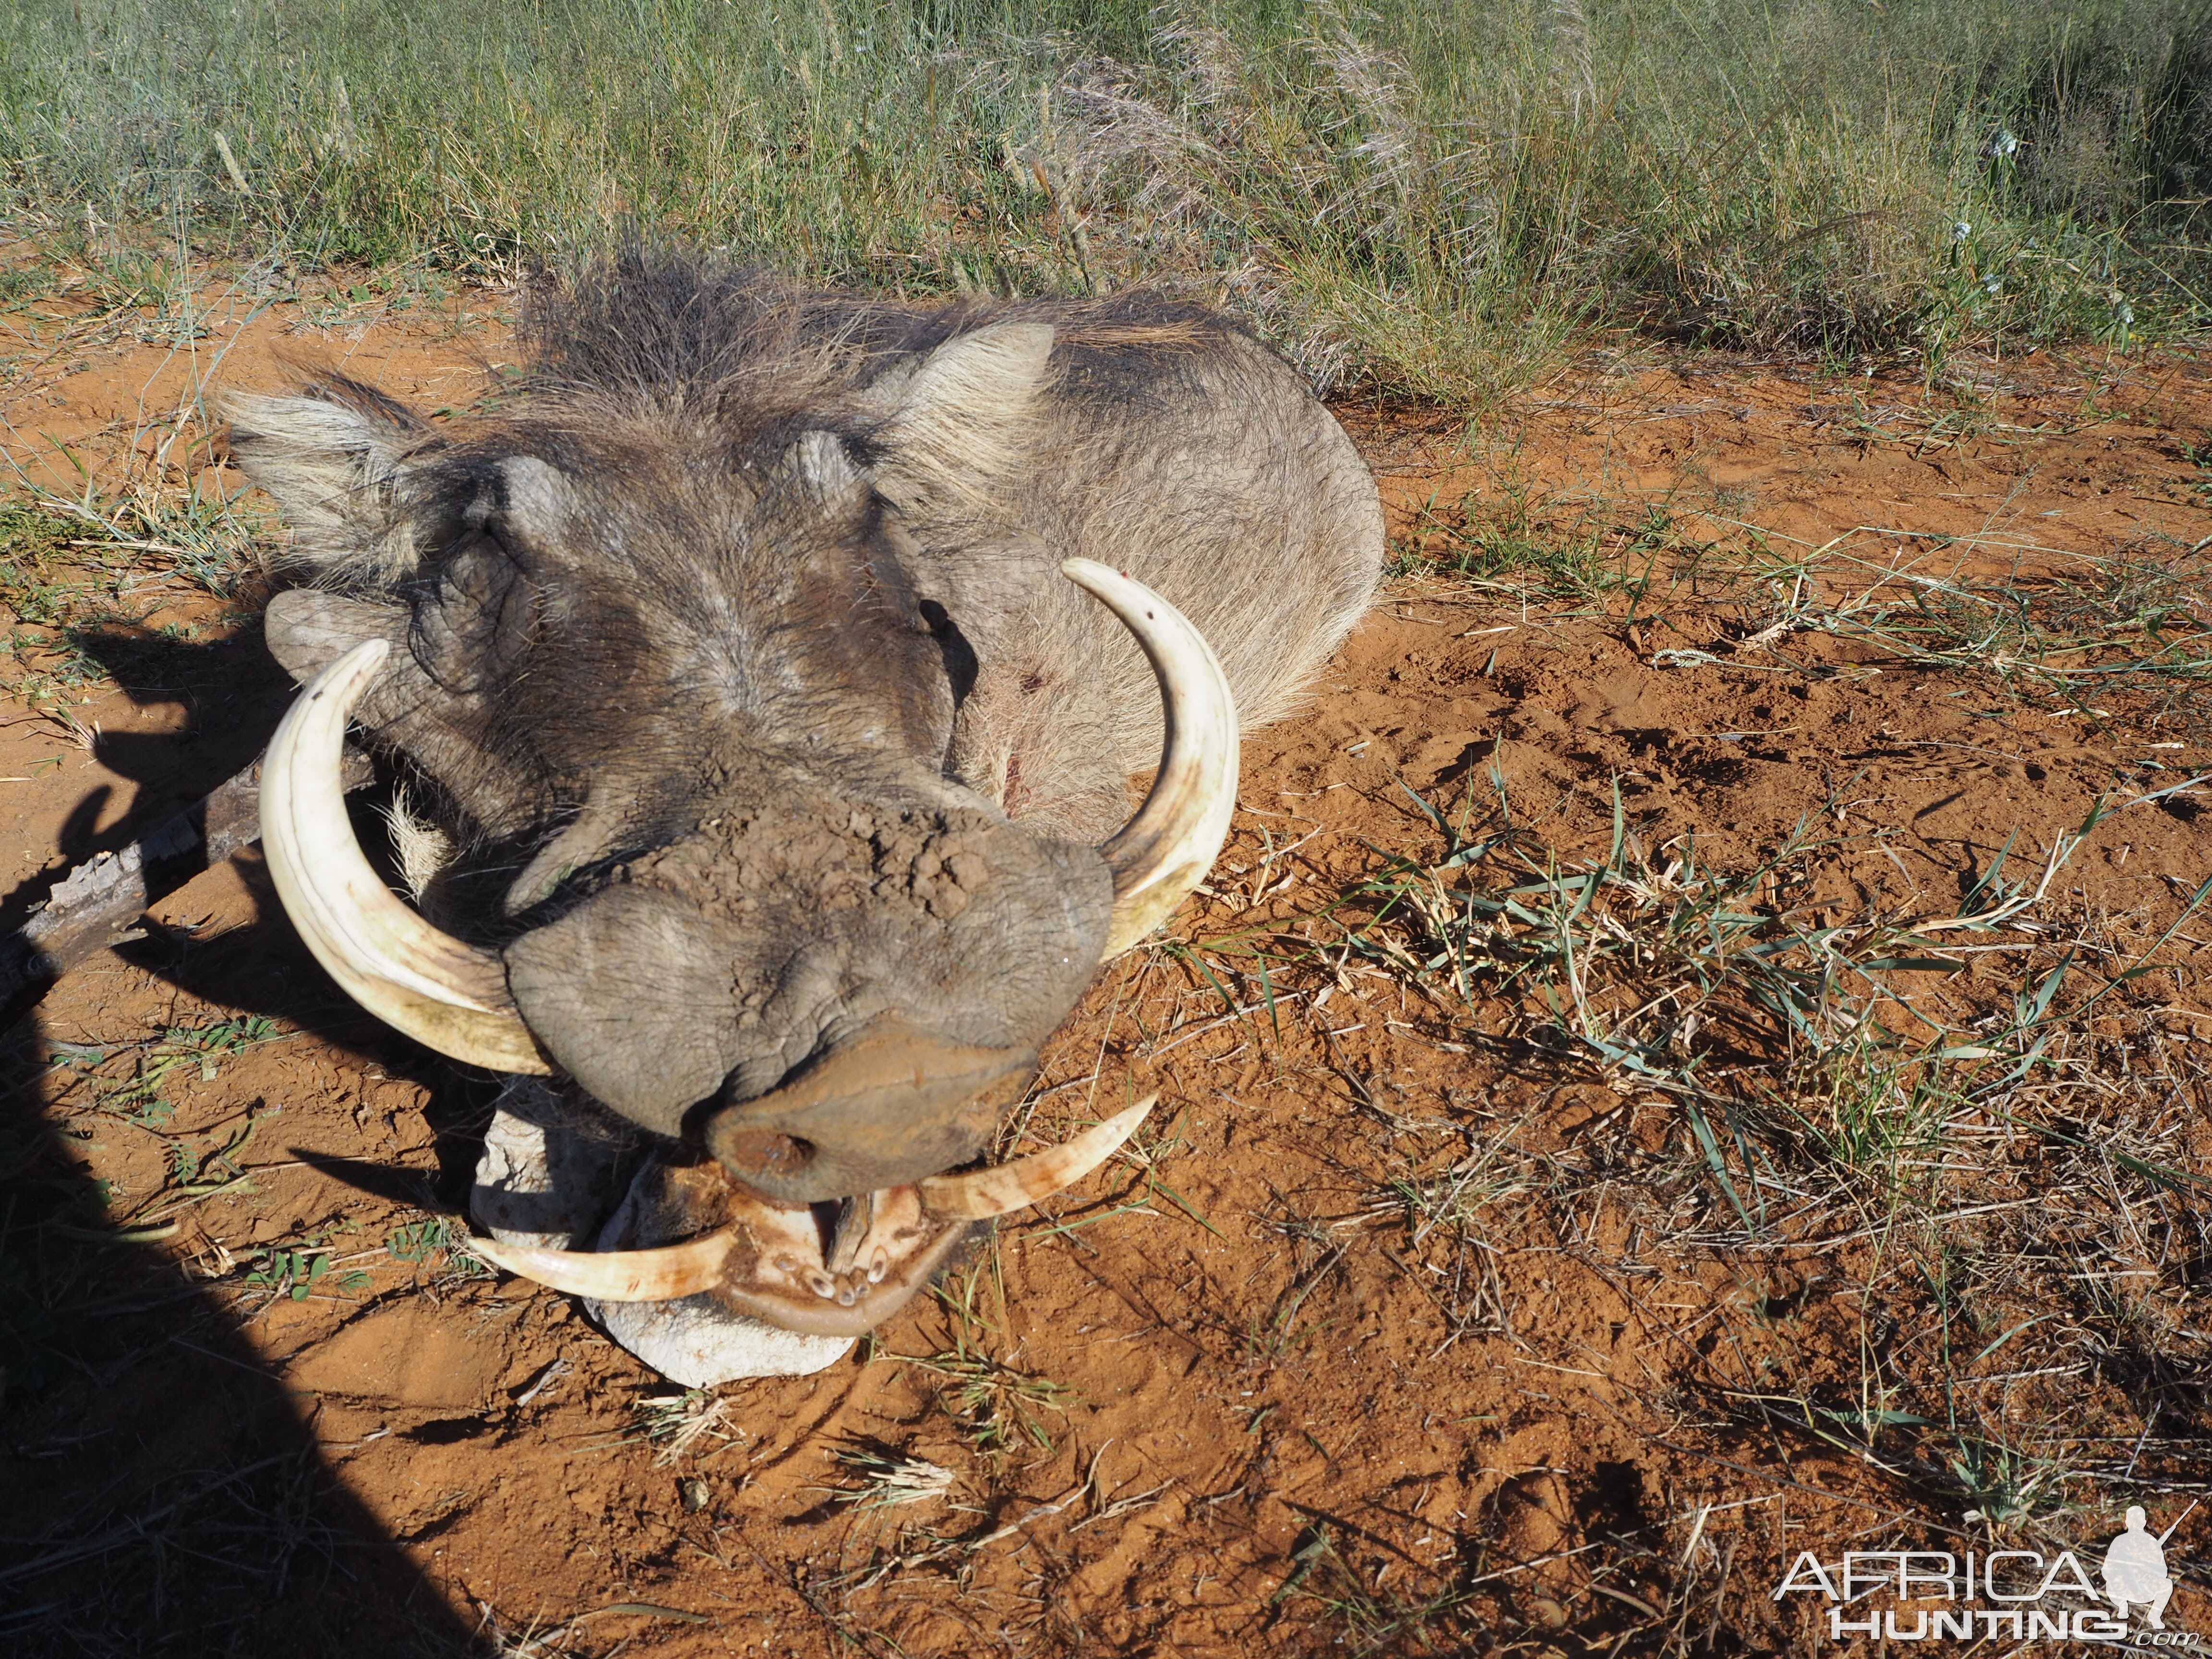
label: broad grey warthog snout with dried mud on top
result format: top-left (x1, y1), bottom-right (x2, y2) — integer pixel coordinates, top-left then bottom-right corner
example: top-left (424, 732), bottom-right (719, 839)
top-left (505, 796), bottom-right (1115, 1199)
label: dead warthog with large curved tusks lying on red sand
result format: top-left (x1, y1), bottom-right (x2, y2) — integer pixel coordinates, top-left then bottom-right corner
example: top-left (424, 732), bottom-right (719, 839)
top-left (226, 252), bottom-right (1382, 1380)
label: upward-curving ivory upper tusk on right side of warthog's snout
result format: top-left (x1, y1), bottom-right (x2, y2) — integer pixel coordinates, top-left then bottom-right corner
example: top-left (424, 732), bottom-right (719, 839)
top-left (1059, 560), bottom-right (1237, 958)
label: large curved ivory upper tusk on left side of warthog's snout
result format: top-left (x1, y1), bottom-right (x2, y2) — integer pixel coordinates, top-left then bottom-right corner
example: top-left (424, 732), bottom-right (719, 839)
top-left (261, 639), bottom-right (553, 1073)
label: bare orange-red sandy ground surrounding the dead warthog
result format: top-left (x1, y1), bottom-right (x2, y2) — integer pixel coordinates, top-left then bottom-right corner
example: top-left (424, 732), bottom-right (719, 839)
top-left (0, 266), bottom-right (2212, 1657)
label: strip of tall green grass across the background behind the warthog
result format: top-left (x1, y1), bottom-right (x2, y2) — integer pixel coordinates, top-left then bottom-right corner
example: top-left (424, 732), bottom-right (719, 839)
top-left (0, 0), bottom-right (2212, 400)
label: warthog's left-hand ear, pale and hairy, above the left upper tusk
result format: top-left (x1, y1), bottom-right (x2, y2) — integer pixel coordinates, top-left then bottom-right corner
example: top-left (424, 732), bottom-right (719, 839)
top-left (217, 376), bottom-right (436, 579)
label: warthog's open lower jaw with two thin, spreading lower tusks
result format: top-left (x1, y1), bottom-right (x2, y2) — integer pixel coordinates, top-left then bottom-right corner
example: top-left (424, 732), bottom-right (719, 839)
top-left (469, 1095), bottom-right (1159, 1336)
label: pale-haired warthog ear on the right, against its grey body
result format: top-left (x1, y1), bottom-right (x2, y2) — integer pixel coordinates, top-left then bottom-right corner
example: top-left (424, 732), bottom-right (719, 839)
top-left (869, 319), bottom-right (1053, 506)
